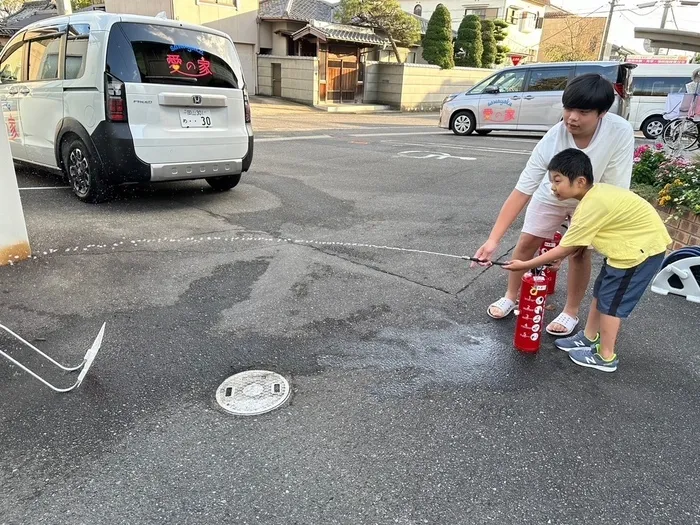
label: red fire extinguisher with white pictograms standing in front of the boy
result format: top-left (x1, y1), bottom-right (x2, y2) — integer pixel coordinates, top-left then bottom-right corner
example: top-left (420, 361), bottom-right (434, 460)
top-left (513, 272), bottom-right (547, 352)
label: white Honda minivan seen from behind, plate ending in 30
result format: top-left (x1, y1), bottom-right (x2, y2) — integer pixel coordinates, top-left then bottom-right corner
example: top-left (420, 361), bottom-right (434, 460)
top-left (0, 11), bottom-right (253, 202)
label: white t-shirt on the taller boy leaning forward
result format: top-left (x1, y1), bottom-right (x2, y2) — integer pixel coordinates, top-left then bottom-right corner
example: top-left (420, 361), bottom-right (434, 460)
top-left (515, 113), bottom-right (634, 208)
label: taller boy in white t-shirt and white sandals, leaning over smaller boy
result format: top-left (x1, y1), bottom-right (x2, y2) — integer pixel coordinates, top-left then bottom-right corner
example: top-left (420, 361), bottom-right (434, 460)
top-left (474, 74), bottom-right (634, 336)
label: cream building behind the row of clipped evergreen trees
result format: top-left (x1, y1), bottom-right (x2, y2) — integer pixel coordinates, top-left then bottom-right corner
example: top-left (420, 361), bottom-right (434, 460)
top-left (399, 0), bottom-right (549, 63)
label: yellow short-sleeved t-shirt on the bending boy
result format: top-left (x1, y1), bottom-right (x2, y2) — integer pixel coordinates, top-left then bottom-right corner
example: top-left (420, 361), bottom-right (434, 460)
top-left (561, 183), bottom-right (672, 269)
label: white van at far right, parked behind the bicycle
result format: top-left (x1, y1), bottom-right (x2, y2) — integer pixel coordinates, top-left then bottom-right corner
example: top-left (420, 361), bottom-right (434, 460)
top-left (629, 64), bottom-right (700, 139)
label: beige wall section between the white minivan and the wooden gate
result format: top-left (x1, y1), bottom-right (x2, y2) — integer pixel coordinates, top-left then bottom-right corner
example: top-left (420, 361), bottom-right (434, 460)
top-left (258, 55), bottom-right (319, 105)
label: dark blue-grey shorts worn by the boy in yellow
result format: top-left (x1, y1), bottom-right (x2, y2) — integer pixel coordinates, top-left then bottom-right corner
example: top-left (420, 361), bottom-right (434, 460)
top-left (593, 253), bottom-right (665, 319)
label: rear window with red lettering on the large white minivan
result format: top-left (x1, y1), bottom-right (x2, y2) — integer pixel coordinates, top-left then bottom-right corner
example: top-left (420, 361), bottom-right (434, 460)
top-left (107, 22), bottom-right (240, 89)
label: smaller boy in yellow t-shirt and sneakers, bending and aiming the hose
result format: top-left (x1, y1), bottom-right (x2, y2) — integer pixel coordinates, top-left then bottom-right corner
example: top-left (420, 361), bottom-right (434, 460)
top-left (504, 149), bottom-right (671, 372)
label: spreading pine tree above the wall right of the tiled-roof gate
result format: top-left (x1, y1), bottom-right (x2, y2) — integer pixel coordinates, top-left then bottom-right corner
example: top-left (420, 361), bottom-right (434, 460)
top-left (338, 0), bottom-right (420, 63)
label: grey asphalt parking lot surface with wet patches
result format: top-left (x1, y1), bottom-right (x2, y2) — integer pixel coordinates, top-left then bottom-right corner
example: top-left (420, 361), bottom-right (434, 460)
top-left (0, 115), bottom-right (700, 525)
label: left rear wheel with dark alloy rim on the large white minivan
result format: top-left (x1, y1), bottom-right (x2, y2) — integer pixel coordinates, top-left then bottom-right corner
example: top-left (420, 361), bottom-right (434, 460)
top-left (61, 137), bottom-right (112, 204)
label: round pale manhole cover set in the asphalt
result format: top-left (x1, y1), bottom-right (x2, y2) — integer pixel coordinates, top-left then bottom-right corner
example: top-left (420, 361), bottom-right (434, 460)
top-left (216, 370), bottom-right (289, 416)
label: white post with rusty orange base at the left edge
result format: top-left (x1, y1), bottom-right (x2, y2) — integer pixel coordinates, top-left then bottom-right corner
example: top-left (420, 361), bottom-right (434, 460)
top-left (0, 111), bottom-right (32, 266)
